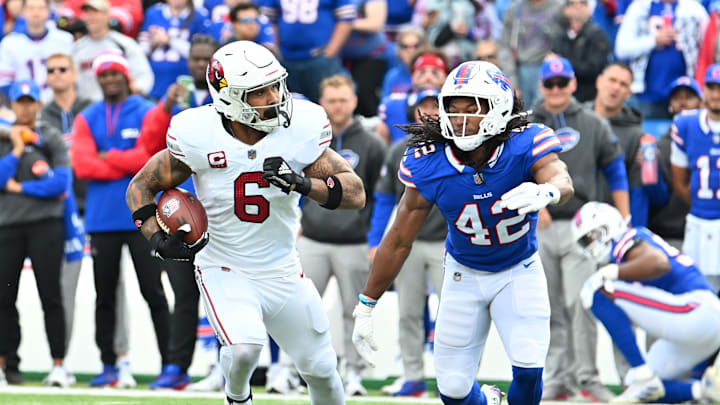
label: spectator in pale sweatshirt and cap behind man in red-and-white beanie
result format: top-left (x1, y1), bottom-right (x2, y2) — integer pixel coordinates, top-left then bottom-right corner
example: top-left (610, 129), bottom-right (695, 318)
top-left (72, 0), bottom-right (155, 101)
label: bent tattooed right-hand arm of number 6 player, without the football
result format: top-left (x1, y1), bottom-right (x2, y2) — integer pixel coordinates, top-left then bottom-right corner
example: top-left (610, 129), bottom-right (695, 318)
top-left (305, 148), bottom-right (365, 208)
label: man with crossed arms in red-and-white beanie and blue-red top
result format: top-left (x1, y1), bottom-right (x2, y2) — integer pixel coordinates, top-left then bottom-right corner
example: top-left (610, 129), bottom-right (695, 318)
top-left (70, 51), bottom-right (170, 386)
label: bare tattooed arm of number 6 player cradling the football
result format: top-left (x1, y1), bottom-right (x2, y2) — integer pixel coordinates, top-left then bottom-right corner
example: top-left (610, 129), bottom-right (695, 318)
top-left (125, 149), bottom-right (192, 239)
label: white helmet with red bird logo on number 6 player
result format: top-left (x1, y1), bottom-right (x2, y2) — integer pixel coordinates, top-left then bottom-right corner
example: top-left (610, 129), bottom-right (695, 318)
top-left (206, 41), bottom-right (292, 132)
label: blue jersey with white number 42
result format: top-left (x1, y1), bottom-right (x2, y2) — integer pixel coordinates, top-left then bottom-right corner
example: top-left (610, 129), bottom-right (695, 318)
top-left (398, 124), bottom-right (560, 272)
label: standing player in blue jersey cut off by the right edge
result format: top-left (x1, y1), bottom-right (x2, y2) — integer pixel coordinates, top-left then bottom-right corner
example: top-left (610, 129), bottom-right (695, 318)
top-left (670, 63), bottom-right (720, 292)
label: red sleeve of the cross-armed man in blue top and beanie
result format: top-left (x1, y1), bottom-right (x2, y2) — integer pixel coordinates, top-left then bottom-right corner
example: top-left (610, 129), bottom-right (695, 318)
top-left (70, 114), bottom-right (126, 180)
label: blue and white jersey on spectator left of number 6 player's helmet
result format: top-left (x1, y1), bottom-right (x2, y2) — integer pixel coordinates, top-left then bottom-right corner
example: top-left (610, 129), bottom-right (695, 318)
top-left (138, 3), bottom-right (210, 100)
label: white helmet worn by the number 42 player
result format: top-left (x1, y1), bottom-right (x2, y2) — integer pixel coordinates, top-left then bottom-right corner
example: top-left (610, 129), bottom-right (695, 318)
top-left (438, 61), bottom-right (513, 151)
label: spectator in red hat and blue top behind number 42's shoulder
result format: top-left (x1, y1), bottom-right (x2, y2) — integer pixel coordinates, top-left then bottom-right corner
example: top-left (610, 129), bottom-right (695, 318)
top-left (375, 49), bottom-right (448, 144)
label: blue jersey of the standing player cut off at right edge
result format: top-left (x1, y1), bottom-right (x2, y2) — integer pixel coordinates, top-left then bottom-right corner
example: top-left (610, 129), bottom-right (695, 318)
top-left (670, 110), bottom-right (720, 219)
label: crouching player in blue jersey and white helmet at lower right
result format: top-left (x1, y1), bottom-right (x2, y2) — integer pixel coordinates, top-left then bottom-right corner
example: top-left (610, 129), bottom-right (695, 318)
top-left (572, 202), bottom-right (720, 403)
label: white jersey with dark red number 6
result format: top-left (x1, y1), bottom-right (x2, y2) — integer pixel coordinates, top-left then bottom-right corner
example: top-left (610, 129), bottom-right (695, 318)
top-left (167, 100), bottom-right (332, 279)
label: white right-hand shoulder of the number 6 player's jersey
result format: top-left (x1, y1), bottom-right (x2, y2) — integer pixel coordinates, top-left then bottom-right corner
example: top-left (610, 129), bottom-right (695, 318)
top-left (290, 99), bottom-right (332, 147)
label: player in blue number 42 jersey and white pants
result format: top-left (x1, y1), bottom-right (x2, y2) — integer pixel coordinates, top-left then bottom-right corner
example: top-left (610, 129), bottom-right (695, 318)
top-left (353, 61), bottom-right (573, 405)
